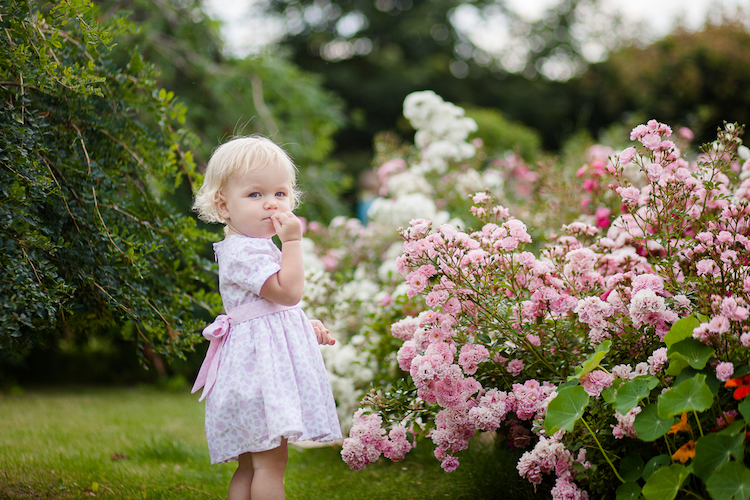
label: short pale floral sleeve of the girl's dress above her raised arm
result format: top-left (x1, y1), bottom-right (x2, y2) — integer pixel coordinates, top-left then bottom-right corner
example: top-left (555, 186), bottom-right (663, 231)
top-left (230, 238), bottom-right (281, 295)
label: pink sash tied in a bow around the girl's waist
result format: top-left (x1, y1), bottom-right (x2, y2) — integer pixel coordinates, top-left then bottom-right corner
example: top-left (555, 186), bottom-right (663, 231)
top-left (190, 299), bottom-right (299, 401)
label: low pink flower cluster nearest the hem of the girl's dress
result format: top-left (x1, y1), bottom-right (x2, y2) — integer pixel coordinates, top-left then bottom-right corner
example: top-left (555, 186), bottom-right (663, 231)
top-left (341, 409), bottom-right (412, 470)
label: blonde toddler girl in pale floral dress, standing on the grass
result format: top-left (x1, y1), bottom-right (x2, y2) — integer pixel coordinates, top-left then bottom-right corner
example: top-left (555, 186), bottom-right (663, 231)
top-left (193, 137), bottom-right (341, 500)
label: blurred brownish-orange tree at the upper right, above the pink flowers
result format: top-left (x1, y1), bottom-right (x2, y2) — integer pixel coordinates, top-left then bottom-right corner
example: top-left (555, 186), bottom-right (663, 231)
top-left (571, 20), bottom-right (750, 146)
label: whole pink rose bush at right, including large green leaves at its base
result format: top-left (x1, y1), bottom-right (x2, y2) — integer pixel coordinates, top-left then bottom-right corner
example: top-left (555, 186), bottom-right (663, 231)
top-left (342, 109), bottom-right (750, 499)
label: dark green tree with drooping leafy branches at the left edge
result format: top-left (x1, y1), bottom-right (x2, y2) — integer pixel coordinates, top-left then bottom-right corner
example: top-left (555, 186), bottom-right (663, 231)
top-left (0, 0), bottom-right (218, 356)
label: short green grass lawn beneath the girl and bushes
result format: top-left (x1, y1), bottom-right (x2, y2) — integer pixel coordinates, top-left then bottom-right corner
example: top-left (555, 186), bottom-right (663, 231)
top-left (0, 388), bottom-right (547, 500)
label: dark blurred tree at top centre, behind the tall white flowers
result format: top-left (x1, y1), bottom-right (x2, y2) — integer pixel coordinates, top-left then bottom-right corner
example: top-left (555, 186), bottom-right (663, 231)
top-left (258, 0), bottom-right (632, 158)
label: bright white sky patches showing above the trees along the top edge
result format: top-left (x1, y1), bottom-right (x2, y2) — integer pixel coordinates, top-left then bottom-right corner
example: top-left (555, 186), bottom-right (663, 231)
top-left (204, 0), bottom-right (750, 60)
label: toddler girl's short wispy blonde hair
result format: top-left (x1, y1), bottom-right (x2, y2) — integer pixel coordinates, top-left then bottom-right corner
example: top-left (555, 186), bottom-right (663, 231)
top-left (193, 135), bottom-right (300, 223)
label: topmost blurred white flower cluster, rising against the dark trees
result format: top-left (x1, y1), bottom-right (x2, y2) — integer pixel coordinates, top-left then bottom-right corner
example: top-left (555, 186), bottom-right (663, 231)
top-left (404, 90), bottom-right (477, 173)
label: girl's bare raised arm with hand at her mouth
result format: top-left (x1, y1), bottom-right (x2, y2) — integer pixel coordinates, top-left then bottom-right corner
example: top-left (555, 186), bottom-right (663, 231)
top-left (260, 212), bottom-right (305, 306)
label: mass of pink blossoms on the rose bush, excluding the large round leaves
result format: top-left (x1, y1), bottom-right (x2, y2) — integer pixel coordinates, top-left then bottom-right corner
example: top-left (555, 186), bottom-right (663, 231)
top-left (345, 120), bottom-right (750, 499)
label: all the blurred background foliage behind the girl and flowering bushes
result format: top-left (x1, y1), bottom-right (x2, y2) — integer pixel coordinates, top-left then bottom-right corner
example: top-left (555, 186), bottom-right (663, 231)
top-left (0, 0), bottom-right (750, 388)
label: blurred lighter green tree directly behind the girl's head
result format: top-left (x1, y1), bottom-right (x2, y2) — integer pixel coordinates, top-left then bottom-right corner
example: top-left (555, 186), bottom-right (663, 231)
top-left (101, 0), bottom-right (350, 221)
